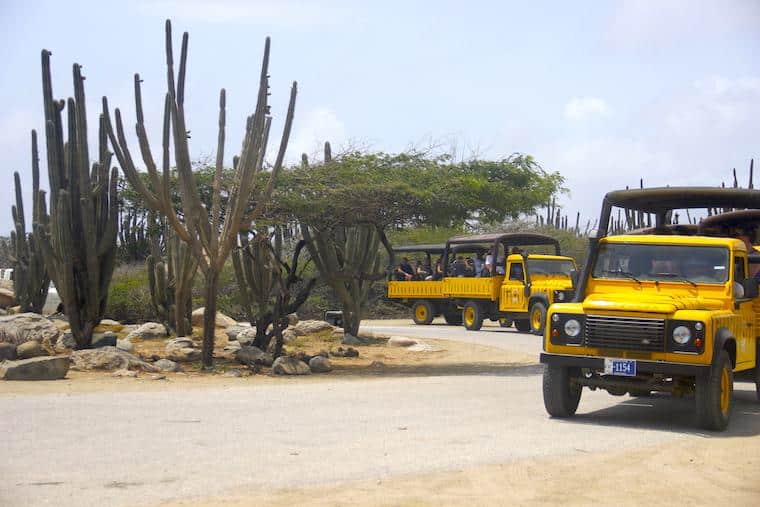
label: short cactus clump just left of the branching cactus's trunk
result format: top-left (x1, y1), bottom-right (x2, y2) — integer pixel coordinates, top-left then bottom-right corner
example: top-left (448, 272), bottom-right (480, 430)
top-left (147, 213), bottom-right (198, 336)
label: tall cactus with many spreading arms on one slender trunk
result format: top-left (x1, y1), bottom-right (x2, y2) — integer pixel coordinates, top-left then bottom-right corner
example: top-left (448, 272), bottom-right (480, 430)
top-left (104, 21), bottom-right (296, 367)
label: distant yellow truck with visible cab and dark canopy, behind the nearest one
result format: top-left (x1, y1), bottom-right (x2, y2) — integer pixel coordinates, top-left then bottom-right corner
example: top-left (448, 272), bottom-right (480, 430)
top-left (442, 233), bottom-right (576, 334)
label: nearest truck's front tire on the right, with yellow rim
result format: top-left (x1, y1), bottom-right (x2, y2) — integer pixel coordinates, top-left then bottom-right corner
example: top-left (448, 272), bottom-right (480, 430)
top-left (695, 350), bottom-right (734, 431)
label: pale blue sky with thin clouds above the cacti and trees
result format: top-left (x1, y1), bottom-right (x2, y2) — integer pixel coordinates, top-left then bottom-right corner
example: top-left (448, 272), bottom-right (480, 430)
top-left (0, 0), bottom-right (760, 234)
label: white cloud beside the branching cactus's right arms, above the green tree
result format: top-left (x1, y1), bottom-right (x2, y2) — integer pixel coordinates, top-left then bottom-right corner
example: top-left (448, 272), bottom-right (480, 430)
top-left (287, 107), bottom-right (346, 163)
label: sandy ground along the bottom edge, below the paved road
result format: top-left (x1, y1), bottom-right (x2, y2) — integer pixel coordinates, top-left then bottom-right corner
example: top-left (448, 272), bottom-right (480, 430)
top-left (161, 436), bottom-right (760, 507)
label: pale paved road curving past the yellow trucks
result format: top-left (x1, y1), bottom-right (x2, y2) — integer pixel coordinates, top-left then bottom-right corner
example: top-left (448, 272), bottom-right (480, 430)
top-left (0, 326), bottom-right (760, 507)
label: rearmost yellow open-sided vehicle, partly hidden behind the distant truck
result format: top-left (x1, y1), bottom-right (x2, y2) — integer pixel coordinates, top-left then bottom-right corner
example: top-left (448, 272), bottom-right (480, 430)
top-left (388, 244), bottom-right (462, 325)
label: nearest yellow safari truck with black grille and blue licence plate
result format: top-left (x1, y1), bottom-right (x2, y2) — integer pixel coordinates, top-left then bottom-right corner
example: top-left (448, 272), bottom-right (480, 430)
top-left (541, 187), bottom-right (760, 430)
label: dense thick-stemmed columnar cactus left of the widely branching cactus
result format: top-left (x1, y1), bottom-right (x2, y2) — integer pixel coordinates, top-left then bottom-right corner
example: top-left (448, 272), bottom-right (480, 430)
top-left (34, 50), bottom-right (119, 348)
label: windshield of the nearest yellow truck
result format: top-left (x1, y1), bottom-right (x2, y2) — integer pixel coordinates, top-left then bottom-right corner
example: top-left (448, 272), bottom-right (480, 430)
top-left (592, 243), bottom-right (729, 285)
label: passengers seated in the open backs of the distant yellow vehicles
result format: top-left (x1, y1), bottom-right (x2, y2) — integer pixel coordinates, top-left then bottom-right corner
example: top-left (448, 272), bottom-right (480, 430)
top-left (393, 248), bottom-right (521, 282)
